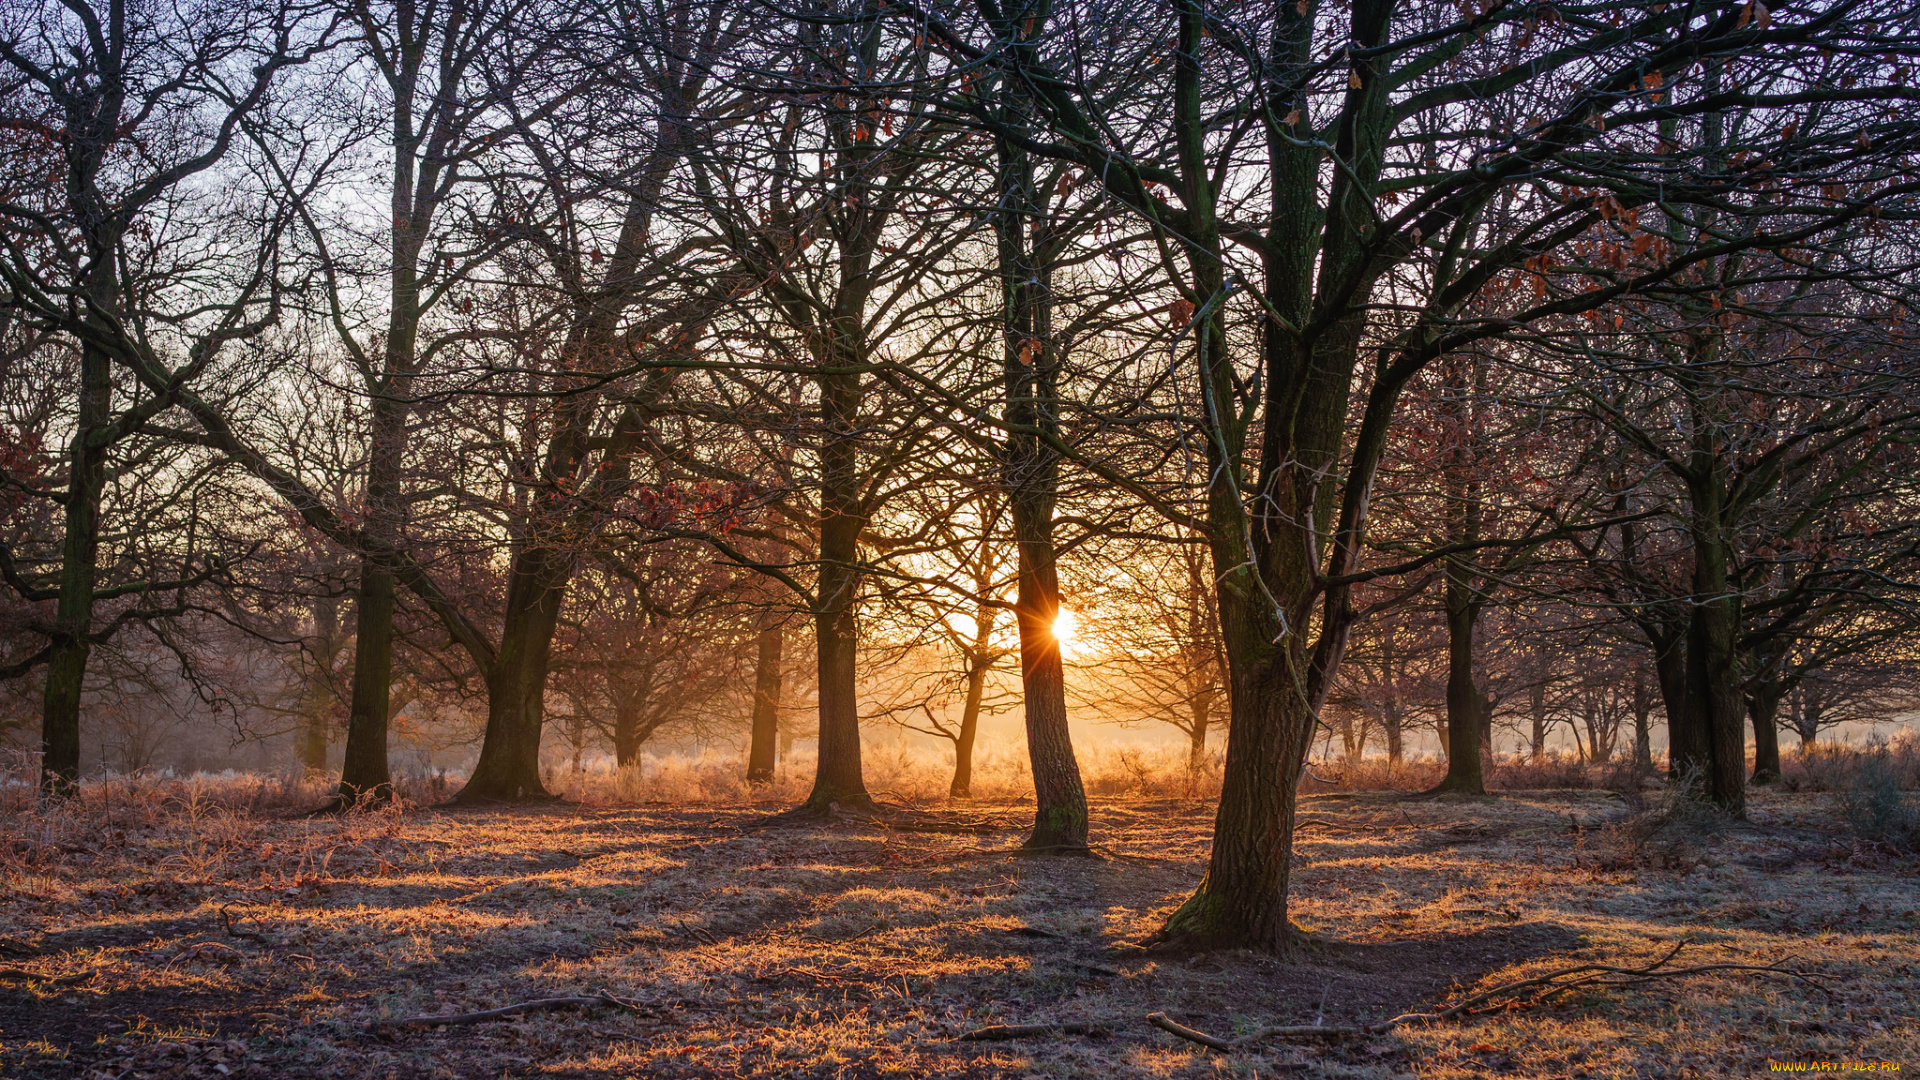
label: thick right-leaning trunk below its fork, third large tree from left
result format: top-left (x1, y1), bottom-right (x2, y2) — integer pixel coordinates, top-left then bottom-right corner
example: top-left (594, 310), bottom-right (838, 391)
top-left (453, 548), bottom-right (572, 805)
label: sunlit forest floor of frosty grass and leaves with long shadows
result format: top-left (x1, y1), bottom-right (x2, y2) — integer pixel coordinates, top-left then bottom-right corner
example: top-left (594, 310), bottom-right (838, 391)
top-left (0, 780), bottom-right (1920, 1080)
